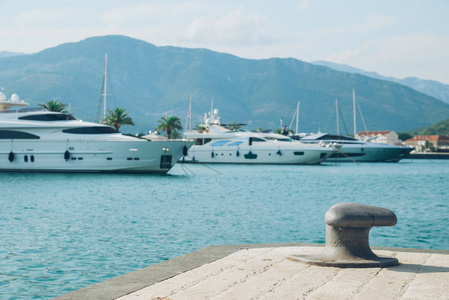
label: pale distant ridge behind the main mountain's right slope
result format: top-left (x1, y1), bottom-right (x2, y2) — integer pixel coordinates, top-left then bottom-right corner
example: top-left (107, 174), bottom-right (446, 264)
top-left (312, 60), bottom-right (449, 103)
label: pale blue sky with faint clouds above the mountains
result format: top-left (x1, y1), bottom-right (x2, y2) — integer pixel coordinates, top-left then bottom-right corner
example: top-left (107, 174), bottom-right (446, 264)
top-left (0, 0), bottom-right (449, 84)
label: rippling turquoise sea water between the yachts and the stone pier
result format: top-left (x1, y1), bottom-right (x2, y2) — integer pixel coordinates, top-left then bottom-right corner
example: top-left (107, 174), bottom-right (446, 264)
top-left (0, 160), bottom-right (449, 299)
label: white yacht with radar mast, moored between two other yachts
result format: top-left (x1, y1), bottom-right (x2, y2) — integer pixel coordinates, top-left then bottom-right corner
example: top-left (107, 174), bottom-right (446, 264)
top-left (181, 110), bottom-right (337, 164)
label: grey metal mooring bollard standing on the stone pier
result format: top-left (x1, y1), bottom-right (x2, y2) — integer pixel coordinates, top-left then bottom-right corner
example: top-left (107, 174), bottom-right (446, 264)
top-left (292, 202), bottom-right (399, 268)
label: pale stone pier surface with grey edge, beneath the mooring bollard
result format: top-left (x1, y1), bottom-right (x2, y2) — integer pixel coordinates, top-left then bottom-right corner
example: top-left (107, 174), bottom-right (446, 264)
top-left (56, 244), bottom-right (449, 300)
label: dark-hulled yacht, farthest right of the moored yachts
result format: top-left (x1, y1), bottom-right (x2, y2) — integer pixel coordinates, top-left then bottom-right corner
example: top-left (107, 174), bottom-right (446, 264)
top-left (300, 133), bottom-right (413, 162)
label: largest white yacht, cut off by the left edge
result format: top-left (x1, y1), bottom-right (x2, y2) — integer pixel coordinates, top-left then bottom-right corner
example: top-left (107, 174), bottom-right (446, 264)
top-left (0, 93), bottom-right (194, 173)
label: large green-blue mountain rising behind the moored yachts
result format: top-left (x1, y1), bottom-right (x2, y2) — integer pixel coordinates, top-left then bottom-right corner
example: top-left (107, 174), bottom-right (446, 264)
top-left (0, 36), bottom-right (449, 133)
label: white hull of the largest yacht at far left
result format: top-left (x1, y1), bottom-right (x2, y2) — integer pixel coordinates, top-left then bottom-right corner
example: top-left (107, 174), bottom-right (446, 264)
top-left (0, 139), bottom-right (193, 173)
